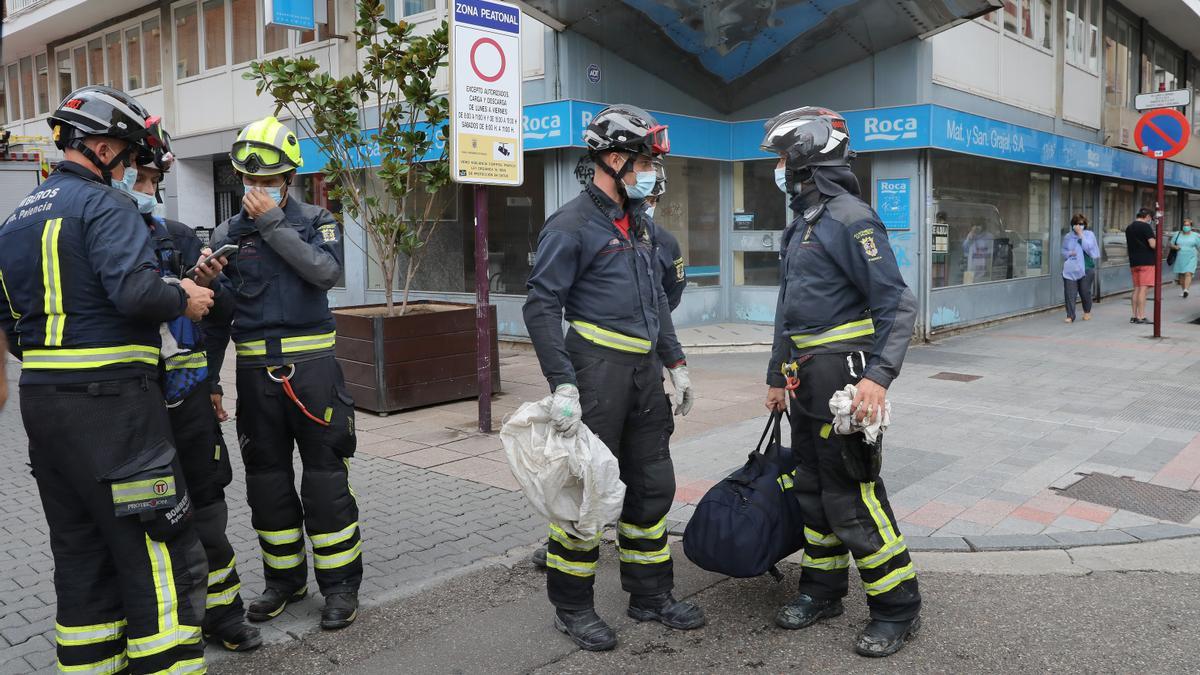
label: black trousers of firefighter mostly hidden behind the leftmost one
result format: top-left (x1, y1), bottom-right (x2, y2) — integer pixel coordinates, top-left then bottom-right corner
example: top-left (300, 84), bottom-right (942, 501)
top-left (167, 386), bottom-right (245, 633)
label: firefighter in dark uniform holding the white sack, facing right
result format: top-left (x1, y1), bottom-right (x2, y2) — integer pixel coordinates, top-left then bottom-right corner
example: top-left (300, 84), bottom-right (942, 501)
top-left (524, 106), bottom-right (704, 650)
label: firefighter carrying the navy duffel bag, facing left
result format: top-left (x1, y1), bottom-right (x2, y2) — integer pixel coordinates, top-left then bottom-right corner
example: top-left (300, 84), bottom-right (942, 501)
top-left (762, 107), bottom-right (920, 656)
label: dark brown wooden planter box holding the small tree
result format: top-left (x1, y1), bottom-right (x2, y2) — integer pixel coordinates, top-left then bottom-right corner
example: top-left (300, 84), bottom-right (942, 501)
top-left (334, 300), bottom-right (500, 413)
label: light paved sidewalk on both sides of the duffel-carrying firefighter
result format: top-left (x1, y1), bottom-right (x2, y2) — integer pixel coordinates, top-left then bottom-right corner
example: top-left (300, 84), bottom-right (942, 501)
top-left (671, 287), bottom-right (1200, 550)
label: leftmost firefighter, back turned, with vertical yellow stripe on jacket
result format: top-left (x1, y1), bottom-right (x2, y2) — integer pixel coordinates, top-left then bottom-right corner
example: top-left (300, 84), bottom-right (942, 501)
top-left (0, 86), bottom-right (212, 673)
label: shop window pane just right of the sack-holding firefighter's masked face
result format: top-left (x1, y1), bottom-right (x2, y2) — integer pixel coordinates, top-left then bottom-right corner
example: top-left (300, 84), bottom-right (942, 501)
top-left (654, 157), bottom-right (720, 287)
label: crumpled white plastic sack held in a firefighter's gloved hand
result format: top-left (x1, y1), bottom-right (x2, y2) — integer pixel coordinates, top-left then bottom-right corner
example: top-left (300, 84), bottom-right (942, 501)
top-left (500, 396), bottom-right (625, 539)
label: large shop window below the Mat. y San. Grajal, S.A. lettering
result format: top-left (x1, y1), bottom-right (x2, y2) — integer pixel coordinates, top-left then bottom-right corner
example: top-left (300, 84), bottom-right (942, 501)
top-left (931, 153), bottom-right (1050, 288)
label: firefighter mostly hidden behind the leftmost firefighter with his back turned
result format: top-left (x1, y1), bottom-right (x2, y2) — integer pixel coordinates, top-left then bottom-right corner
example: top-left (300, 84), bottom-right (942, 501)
top-left (133, 135), bottom-right (263, 651)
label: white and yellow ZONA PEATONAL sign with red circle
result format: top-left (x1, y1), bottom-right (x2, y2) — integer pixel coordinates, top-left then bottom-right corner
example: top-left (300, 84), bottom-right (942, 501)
top-left (450, 0), bottom-right (524, 186)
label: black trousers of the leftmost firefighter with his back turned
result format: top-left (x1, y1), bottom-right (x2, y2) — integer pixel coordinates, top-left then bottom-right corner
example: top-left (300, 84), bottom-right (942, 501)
top-left (20, 376), bottom-right (208, 673)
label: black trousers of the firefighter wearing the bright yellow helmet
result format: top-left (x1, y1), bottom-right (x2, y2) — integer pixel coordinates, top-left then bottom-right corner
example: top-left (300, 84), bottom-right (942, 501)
top-left (238, 354), bottom-right (362, 596)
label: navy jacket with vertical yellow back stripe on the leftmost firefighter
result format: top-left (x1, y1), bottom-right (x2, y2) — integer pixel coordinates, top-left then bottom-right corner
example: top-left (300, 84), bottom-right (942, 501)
top-left (0, 162), bottom-right (187, 384)
